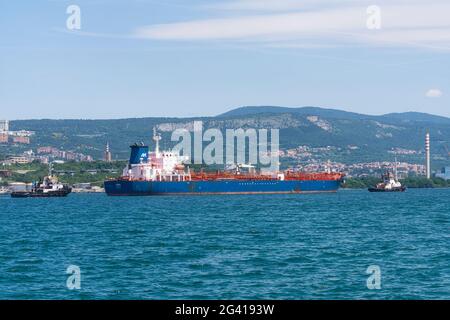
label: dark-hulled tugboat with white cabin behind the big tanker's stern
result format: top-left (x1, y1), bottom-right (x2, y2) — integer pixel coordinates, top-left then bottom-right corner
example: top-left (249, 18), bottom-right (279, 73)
top-left (11, 164), bottom-right (72, 198)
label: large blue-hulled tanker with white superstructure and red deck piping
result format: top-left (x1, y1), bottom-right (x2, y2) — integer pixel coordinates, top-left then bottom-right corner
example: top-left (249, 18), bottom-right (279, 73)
top-left (104, 131), bottom-right (343, 196)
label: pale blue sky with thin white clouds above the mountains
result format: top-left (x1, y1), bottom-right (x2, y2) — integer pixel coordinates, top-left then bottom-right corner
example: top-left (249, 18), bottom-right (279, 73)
top-left (0, 0), bottom-right (450, 120)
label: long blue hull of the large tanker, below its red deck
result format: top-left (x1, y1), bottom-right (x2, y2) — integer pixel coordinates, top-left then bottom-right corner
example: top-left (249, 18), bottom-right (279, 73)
top-left (105, 180), bottom-right (341, 196)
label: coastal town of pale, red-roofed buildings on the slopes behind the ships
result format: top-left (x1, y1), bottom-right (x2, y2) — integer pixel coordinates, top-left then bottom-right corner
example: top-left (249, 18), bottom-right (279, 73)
top-left (0, 120), bottom-right (450, 189)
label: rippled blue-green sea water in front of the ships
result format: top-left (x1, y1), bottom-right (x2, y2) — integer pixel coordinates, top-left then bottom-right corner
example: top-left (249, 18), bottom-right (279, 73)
top-left (0, 189), bottom-right (450, 299)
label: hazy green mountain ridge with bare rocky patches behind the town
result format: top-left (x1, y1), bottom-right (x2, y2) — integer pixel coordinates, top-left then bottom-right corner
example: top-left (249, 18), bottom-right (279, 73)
top-left (0, 106), bottom-right (450, 165)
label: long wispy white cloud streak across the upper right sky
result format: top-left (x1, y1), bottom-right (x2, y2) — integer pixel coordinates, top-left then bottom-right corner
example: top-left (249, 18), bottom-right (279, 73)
top-left (134, 0), bottom-right (450, 50)
